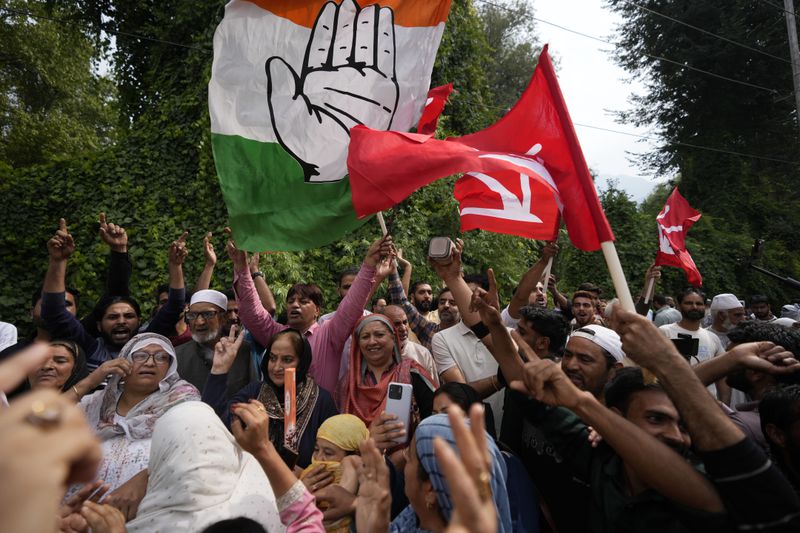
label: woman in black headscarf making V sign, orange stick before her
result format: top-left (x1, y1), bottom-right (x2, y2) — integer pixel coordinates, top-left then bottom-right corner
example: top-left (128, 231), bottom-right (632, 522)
top-left (203, 328), bottom-right (338, 468)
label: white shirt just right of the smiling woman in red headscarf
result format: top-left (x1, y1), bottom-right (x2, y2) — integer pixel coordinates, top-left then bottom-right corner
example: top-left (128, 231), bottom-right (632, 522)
top-left (431, 322), bottom-right (505, 435)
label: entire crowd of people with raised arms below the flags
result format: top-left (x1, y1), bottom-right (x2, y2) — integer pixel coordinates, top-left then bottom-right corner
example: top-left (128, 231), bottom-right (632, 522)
top-left (0, 215), bottom-right (800, 533)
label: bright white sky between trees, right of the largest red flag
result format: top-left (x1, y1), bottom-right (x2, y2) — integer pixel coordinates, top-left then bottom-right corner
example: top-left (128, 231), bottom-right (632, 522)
top-left (528, 0), bottom-right (660, 200)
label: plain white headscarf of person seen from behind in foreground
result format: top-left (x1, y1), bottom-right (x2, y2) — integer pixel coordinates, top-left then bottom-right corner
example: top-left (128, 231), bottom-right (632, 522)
top-left (126, 402), bottom-right (285, 533)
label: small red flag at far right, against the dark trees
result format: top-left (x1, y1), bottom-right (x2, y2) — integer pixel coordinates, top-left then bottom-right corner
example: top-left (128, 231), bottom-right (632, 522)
top-left (656, 187), bottom-right (703, 287)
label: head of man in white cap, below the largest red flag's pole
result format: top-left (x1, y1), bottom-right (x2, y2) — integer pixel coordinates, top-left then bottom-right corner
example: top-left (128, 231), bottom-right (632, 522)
top-left (561, 324), bottom-right (625, 398)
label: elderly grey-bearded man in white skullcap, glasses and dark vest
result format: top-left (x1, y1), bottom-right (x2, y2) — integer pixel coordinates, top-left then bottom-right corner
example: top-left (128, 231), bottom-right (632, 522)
top-left (175, 290), bottom-right (258, 399)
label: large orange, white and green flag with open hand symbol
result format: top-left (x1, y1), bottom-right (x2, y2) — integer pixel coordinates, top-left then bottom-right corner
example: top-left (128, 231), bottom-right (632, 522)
top-left (208, 0), bottom-right (450, 251)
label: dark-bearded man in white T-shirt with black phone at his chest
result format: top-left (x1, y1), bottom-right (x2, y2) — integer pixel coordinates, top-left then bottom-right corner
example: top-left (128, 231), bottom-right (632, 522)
top-left (658, 287), bottom-right (730, 396)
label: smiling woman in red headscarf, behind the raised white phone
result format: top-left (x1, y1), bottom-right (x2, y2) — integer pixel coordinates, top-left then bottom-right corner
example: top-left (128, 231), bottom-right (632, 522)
top-left (337, 315), bottom-right (434, 434)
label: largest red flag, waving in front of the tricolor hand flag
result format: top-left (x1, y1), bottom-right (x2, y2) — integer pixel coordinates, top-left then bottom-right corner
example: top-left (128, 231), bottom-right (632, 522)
top-left (347, 46), bottom-right (614, 251)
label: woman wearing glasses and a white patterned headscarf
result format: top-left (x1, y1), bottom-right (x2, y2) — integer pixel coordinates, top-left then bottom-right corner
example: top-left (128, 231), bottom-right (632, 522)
top-left (73, 333), bottom-right (200, 520)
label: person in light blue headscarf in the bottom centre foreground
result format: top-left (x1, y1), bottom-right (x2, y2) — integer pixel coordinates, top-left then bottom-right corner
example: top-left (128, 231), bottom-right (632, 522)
top-left (390, 414), bottom-right (512, 533)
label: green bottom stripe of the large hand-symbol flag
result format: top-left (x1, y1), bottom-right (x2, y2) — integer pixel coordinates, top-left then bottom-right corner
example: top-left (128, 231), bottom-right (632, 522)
top-left (211, 134), bottom-right (369, 251)
